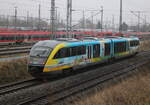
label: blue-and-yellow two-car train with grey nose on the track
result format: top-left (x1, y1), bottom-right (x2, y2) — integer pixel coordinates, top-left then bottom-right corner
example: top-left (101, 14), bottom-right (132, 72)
top-left (28, 37), bottom-right (140, 78)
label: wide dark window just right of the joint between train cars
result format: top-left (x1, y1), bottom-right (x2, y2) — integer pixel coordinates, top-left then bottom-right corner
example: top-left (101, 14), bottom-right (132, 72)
top-left (114, 42), bottom-right (127, 53)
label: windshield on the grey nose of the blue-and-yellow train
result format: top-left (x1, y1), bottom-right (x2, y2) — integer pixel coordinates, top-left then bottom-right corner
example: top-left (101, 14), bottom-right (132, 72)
top-left (30, 46), bottom-right (52, 57)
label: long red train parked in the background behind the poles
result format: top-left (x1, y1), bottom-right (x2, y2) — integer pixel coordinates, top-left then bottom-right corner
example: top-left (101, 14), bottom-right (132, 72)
top-left (0, 30), bottom-right (150, 45)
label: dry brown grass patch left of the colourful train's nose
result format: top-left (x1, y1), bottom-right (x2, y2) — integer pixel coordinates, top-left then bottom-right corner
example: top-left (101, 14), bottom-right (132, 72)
top-left (0, 59), bottom-right (31, 84)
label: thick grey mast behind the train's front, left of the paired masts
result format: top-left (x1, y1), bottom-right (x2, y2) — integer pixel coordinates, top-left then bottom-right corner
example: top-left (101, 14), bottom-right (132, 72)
top-left (51, 0), bottom-right (55, 39)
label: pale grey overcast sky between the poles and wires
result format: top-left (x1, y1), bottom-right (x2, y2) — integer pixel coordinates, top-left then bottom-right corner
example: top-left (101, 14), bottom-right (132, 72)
top-left (0, 0), bottom-right (150, 24)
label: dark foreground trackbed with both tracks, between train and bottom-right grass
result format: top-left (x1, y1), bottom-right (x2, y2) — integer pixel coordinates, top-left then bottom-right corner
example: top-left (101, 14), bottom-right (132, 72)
top-left (0, 38), bottom-right (150, 105)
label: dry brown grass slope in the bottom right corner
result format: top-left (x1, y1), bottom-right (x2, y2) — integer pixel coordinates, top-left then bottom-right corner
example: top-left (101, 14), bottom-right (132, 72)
top-left (68, 62), bottom-right (150, 105)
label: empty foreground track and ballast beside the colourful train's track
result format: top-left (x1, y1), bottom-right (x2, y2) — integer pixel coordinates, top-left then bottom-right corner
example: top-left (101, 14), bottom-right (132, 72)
top-left (0, 52), bottom-right (150, 105)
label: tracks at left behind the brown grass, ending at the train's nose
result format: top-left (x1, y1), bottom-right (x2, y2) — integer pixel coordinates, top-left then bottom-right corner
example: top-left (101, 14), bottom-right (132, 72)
top-left (0, 46), bottom-right (32, 56)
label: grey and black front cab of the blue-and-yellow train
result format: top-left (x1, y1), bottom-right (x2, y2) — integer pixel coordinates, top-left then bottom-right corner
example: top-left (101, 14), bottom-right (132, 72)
top-left (28, 40), bottom-right (58, 75)
